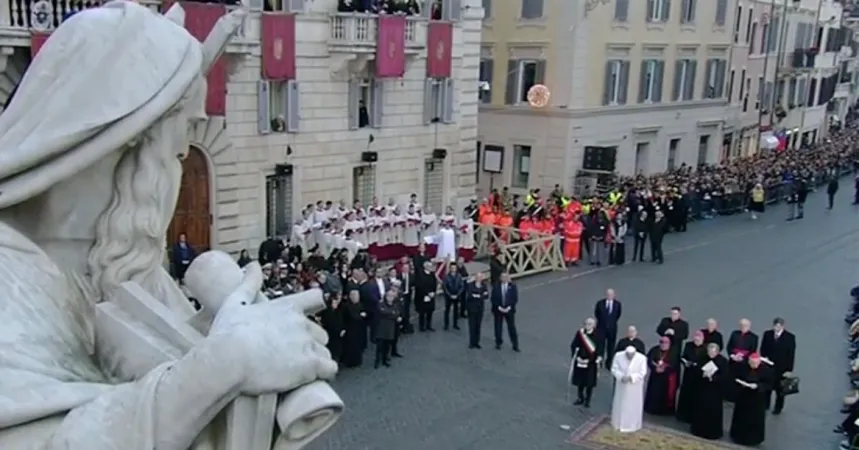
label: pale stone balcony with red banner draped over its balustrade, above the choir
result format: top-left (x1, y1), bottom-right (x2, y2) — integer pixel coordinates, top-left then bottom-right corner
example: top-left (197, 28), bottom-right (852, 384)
top-left (328, 13), bottom-right (427, 54)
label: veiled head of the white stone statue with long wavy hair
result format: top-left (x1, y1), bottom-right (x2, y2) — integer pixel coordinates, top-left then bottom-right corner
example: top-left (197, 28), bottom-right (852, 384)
top-left (0, 1), bottom-right (244, 298)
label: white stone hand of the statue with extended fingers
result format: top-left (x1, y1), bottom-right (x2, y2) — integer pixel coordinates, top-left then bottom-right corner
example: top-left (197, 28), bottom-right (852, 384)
top-left (209, 262), bottom-right (337, 395)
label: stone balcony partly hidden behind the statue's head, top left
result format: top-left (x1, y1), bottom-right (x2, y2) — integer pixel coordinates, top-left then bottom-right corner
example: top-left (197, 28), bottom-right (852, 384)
top-left (0, 0), bottom-right (260, 53)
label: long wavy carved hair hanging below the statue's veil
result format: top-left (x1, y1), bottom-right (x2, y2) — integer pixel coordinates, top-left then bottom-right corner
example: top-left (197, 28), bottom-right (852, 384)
top-left (82, 114), bottom-right (182, 299)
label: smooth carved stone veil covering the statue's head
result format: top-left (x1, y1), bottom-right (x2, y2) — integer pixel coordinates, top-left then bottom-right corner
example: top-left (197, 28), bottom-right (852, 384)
top-left (0, 1), bottom-right (204, 209)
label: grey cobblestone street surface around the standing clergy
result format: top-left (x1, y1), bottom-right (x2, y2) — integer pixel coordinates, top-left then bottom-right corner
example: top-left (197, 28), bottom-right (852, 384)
top-left (311, 187), bottom-right (859, 450)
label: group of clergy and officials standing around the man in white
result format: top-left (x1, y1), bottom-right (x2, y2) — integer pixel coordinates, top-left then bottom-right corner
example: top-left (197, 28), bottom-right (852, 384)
top-left (569, 289), bottom-right (799, 446)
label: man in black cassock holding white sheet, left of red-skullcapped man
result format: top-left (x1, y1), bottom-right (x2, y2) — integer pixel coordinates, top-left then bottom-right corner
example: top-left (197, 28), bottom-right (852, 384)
top-left (690, 343), bottom-right (730, 439)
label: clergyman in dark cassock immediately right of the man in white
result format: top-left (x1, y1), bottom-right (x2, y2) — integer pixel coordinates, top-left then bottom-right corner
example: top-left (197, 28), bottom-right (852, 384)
top-left (644, 336), bottom-right (680, 416)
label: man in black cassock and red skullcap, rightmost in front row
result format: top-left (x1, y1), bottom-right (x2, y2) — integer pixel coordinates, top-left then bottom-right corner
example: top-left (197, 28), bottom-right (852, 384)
top-left (731, 353), bottom-right (772, 447)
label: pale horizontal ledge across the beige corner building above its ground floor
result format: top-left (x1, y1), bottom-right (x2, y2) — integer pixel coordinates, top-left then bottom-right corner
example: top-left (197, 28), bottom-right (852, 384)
top-left (479, 100), bottom-right (728, 119)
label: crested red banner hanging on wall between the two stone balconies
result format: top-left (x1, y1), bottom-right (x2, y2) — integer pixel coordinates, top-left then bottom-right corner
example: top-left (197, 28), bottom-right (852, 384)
top-left (261, 13), bottom-right (295, 81)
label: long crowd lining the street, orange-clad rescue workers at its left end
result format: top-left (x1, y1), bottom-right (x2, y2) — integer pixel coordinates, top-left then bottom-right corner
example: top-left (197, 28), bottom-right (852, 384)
top-left (477, 127), bottom-right (859, 266)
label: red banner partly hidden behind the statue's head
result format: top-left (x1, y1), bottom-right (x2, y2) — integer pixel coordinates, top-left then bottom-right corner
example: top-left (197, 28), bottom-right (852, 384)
top-left (180, 2), bottom-right (227, 116)
